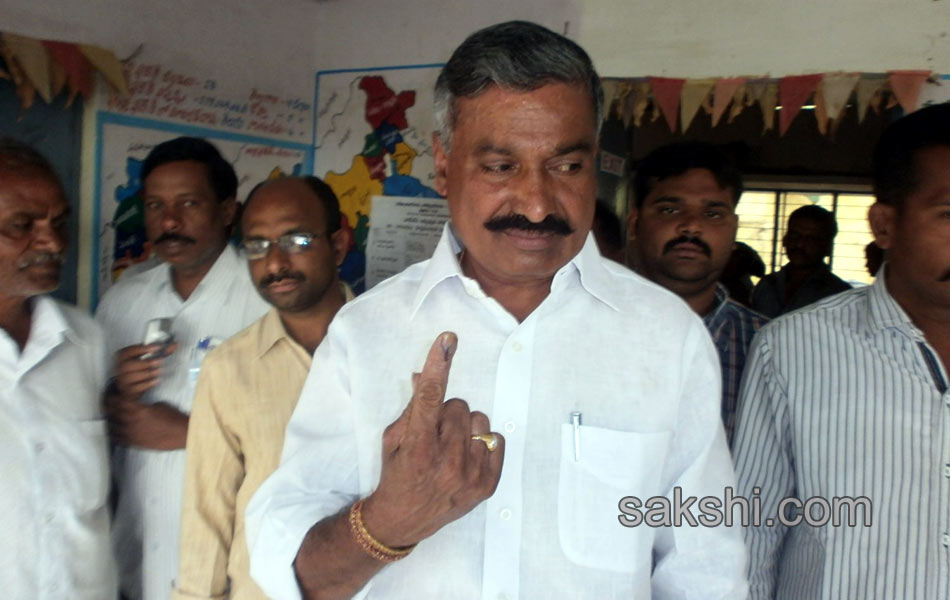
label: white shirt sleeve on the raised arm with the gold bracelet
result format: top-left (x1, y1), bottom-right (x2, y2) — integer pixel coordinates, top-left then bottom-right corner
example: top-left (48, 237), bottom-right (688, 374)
top-left (246, 316), bottom-right (359, 600)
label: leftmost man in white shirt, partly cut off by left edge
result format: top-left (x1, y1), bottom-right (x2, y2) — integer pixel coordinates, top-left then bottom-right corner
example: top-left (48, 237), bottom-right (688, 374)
top-left (0, 139), bottom-right (116, 600)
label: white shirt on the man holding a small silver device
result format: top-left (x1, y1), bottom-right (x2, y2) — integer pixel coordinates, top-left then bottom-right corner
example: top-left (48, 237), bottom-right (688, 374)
top-left (96, 245), bottom-right (270, 600)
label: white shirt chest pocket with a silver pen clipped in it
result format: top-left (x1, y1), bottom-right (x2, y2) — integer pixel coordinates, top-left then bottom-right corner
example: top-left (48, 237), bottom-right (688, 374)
top-left (558, 423), bottom-right (672, 573)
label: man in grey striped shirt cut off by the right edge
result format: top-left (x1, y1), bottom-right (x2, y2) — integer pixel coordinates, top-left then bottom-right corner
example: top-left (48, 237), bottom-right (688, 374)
top-left (735, 104), bottom-right (950, 599)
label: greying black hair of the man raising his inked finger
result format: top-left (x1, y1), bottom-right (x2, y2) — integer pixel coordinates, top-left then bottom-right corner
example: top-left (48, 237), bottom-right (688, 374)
top-left (433, 21), bottom-right (604, 152)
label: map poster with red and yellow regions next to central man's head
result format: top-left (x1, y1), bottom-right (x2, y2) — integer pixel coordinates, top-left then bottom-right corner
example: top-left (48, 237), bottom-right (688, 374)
top-left (313, 65), bottom-right (441, 293)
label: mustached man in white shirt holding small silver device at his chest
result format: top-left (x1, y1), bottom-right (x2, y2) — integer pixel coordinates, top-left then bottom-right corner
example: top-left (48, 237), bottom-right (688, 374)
top-left (96, 138), bottom-right (268, 600)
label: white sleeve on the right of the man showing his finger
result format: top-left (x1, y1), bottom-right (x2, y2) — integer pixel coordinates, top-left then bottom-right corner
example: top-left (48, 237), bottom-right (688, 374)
top-left (651, 319), bottom-right (748, 600)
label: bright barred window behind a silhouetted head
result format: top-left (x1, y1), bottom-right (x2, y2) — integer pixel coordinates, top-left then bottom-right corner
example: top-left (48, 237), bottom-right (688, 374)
top-left (736, 181), bottom-right (874, 284)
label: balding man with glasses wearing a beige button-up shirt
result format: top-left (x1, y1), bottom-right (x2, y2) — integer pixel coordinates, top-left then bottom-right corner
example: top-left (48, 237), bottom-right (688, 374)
top-left (173, 177), bottom-right (349, 600)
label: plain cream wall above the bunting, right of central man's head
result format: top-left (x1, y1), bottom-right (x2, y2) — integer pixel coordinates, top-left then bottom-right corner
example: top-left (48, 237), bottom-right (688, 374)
top-left (575, 0), bottom-right (950, 77)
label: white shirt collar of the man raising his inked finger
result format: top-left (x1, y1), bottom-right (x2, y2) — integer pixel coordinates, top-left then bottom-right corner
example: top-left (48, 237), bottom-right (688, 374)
top-left (410, 221), bottom-right (622, 316)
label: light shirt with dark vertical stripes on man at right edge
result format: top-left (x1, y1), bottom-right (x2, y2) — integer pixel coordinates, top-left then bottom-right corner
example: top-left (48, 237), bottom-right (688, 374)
top-left (735, 268), bottom-right (950, 600)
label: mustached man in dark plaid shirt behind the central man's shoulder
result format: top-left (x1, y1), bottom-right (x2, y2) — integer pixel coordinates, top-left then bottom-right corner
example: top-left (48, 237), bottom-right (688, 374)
top-left (627, 142), bottom-right (768, 446)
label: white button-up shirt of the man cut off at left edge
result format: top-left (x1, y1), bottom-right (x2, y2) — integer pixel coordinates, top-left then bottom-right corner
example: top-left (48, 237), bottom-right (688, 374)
top-left (0, 297), bottom-right (116, 600)
